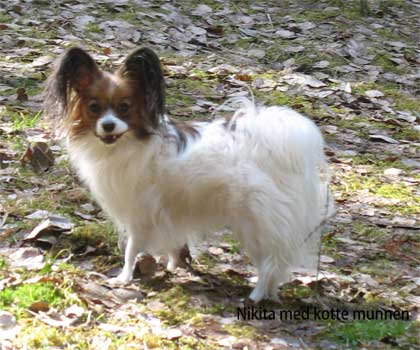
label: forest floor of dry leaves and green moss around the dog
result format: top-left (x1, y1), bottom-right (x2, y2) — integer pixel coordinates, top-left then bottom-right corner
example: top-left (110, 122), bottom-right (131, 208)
top-left (0, 0), bottom-right (420, 350)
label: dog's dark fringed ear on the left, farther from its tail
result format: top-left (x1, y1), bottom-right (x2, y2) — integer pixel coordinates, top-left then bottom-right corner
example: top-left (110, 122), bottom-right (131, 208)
top-left (44, 47), bottom-right (100, 118)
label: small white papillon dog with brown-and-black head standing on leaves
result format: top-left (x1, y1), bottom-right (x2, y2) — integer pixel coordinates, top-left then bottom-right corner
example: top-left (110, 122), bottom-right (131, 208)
top-left (45, 47), bottom-right (332, 302)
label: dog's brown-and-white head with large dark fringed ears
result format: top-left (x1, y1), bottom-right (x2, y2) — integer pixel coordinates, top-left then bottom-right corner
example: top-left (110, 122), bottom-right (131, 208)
top-left (44, 47), bottom-right (165, 144)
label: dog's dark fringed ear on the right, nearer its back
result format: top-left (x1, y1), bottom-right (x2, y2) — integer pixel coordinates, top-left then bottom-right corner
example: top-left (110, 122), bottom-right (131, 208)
top-left (118, 48), bottom-right (165, 129)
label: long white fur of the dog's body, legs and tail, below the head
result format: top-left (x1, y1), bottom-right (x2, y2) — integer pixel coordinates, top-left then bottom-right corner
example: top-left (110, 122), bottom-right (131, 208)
top-left (67, 101), bottom-right (333, 301)
